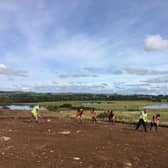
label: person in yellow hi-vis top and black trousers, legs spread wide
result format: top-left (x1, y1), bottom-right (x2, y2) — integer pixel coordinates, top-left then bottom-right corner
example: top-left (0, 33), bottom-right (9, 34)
top-left (136, 110), bottom-right (147, 132)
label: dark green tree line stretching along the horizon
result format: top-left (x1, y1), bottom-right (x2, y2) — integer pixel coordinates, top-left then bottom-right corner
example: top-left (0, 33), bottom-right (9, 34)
top-left (0, 92), bottom-right (168, 104)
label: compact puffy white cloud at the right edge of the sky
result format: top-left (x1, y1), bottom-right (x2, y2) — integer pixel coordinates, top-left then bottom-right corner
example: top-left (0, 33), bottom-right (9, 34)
top-left (145, 35), bottom-right (168, 51)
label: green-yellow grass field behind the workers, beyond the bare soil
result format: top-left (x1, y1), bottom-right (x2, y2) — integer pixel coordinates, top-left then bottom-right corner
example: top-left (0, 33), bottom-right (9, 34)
top-left (29, 101), bottom-right (168, 125)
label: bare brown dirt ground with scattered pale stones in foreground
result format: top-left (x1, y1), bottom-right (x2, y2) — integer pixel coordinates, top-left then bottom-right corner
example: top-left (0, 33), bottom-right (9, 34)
top-left (0, 110), bottom-right (168, 168)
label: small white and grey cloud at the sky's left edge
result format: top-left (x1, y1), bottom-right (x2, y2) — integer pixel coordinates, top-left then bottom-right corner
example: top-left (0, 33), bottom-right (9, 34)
top-left (0, 64), bottom-right (27, 77)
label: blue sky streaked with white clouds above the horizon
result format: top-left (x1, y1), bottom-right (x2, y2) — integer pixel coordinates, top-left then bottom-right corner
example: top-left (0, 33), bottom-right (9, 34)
top-left (0, 0), bottom-right (168, 95)
